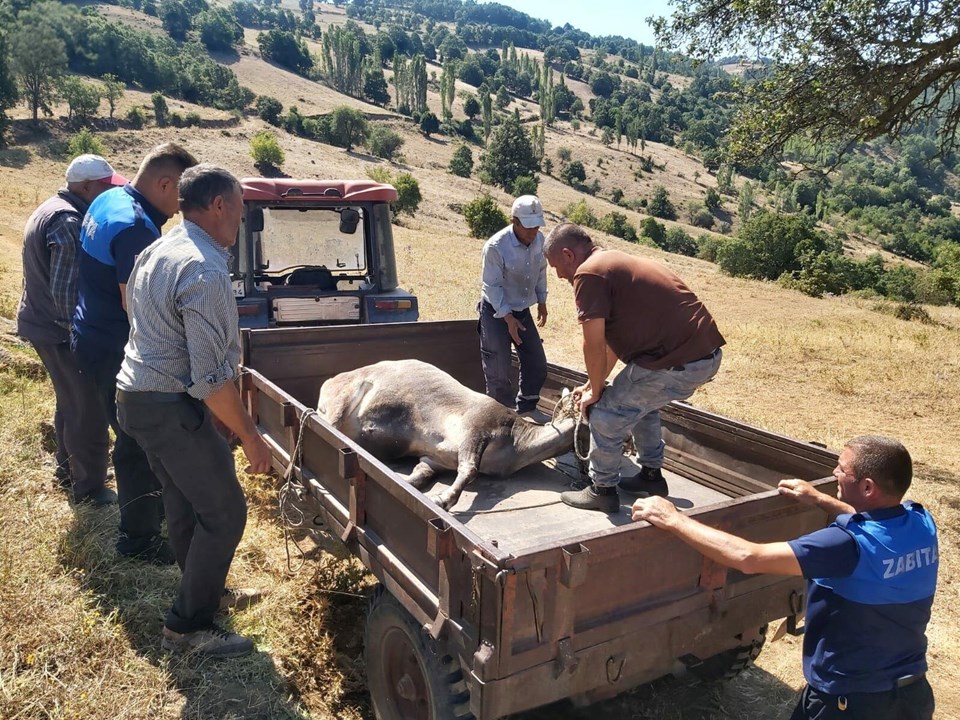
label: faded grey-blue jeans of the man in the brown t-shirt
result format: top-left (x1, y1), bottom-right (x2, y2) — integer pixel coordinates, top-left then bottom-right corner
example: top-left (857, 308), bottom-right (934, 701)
top-left (589, 350), bottom-right (723, 487)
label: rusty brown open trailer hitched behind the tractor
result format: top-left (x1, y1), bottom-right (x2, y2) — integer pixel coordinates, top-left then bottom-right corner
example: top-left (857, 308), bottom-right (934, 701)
top-left (243, 321), bottom-right (836, 720)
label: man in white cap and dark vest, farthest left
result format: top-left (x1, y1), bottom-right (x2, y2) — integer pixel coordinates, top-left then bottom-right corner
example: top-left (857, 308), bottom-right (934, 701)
top-left (17, 155), bottom-right (126, 505)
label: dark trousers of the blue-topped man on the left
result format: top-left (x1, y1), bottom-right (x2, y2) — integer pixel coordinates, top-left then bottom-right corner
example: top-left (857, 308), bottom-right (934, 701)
top-left (73, 338), bottom-right (163, 555)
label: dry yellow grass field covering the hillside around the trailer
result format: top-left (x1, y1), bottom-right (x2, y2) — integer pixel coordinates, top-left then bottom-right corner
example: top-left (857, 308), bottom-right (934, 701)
top-left (0, 8), bottom-right (960, 720)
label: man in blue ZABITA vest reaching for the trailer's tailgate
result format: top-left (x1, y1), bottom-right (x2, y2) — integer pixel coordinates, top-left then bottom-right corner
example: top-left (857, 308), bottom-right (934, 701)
top-left (633, 435), bottom-right (939, 720)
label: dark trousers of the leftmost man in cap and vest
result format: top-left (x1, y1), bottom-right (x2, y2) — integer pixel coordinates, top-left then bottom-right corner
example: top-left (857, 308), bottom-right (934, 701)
top-left (34, 343), bottom-right (110, 498)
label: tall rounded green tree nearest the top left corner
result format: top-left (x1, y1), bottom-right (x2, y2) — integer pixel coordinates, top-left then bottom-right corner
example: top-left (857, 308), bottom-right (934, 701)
top-left (10, 16), bottom-right (67, 122)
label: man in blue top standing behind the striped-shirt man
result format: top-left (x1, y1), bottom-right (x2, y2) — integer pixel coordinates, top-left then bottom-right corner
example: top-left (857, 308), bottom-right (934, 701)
top-left (71, 143), bottom-right (197, 564)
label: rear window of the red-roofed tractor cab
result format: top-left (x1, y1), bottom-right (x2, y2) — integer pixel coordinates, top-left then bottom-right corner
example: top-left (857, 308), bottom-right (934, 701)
top-left (259, 207), bottom-right (367, 275)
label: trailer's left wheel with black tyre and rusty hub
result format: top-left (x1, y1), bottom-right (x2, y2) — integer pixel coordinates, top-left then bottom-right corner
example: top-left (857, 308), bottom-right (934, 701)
top-left (364, 585), bottom-right (473, 720)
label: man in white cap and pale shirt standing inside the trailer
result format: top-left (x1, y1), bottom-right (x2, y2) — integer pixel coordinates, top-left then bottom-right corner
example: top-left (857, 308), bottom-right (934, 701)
top-left (477, 195), bottom-right (547, 413)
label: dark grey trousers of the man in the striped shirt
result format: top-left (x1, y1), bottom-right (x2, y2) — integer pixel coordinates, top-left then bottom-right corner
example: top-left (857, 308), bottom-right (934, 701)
top-left (118, 396), bottom-right (247, 633)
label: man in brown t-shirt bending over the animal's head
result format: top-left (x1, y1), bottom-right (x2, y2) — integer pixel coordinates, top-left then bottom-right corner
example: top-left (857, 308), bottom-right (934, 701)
top-left (543, 223), bottom-right (725, 513)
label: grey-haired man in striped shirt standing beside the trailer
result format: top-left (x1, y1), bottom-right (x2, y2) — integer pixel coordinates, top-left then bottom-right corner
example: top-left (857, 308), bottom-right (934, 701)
top-left (117, 165), bottom-right (271, 657)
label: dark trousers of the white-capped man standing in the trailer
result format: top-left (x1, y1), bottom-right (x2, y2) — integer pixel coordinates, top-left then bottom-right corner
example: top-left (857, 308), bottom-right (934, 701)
top-left (477, 300), bottom-right (547, 412)
